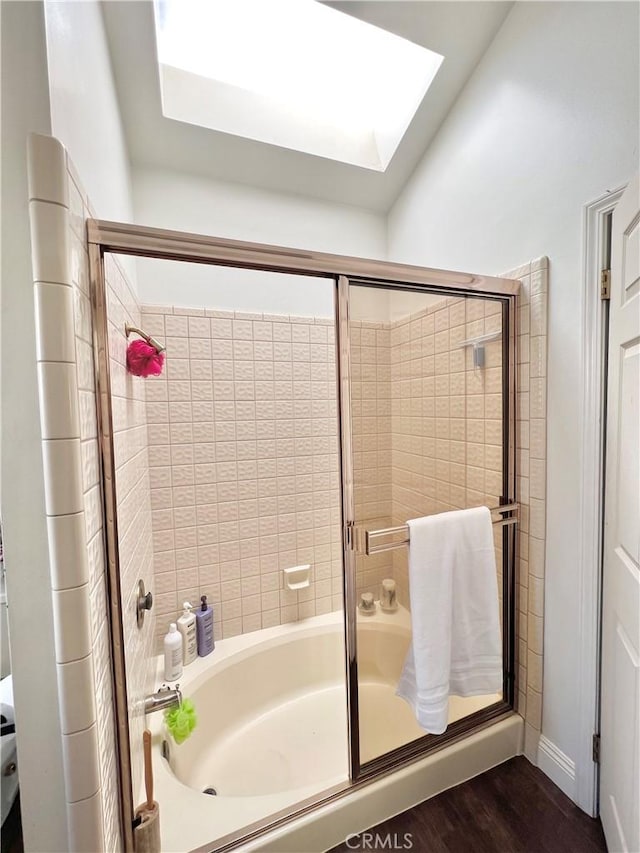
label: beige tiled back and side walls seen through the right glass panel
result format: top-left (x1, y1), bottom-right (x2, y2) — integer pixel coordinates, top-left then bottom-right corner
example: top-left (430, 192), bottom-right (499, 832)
top-left (351, 298), bottom-right (502, 606)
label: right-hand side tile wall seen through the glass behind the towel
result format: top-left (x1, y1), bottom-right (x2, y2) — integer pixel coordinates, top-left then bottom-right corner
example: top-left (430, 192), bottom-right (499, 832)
top-left (391, 298), bottom-right (502, 606)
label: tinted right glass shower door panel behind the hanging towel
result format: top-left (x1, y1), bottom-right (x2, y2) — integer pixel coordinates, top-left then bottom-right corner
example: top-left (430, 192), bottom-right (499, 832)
top-left (349, 284), bottom-right (507, 765)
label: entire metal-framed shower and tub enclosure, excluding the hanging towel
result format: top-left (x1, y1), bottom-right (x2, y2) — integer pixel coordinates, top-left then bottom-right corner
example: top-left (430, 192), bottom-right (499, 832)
top-left (89, 221), bottom-right (519, 849)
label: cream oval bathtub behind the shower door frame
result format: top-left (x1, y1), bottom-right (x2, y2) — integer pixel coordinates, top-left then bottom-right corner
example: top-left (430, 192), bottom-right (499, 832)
top-left (151, 608), bottom-right (522, 851)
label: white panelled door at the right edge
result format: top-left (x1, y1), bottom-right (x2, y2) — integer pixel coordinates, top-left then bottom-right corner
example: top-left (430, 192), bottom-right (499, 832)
top-left (600, 177), bottom-right (640, 853)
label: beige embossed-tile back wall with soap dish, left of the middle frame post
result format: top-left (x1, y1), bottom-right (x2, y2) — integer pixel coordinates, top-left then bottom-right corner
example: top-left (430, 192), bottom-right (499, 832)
top-left (142, 305), bottom-right (342, 648)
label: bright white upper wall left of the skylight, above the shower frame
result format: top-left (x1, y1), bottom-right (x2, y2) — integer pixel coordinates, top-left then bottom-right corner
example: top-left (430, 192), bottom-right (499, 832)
top-left (44, 0), bottom-right (133, 222)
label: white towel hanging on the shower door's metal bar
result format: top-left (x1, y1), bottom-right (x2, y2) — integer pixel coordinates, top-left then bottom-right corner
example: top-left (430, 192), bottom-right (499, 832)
top-left (396, 507), bottom-right (502, 734)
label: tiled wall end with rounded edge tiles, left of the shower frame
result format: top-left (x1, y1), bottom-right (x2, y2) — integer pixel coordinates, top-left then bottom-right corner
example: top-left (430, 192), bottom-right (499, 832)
top-left (29, 130), bottom-right (121, 851)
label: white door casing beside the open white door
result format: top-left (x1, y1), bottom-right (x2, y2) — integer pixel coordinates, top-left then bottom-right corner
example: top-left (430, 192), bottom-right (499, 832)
top-left (575, 187), bottom-right (624, 817)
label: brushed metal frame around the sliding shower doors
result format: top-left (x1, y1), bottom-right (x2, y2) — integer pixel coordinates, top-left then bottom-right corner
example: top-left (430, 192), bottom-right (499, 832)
top-left (87, 219), bottom-right (520, 851)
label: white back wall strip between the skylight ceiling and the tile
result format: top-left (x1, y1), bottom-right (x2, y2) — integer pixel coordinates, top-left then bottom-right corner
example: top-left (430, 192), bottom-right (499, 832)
top-left (133, 168), bottom-right (386, 308)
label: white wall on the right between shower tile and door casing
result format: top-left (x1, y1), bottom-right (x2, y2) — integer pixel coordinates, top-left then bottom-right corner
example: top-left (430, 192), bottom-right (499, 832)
top-left (388, 2), bottom-right (639, 800)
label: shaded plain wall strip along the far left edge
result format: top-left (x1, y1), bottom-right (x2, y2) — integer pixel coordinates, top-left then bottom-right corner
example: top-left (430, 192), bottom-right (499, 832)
top-left (0, 2), bottom-right (69, 851)
